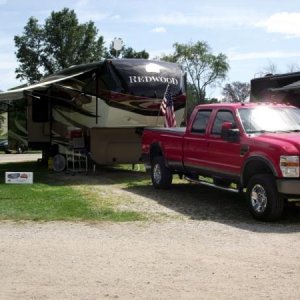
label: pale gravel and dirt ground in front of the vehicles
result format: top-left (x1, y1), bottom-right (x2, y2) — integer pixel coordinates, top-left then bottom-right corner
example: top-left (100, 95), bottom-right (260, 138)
top-left (0, 155), bottom-right (300, 299)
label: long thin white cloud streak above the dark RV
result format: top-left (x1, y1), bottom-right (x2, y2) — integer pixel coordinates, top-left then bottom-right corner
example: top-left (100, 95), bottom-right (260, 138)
top-left (227, 51), bottom-right (300, 61)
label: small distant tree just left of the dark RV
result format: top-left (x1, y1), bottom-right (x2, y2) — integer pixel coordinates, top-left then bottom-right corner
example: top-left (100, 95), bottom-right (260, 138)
top-left (222, 81), bottom-right (250, 102)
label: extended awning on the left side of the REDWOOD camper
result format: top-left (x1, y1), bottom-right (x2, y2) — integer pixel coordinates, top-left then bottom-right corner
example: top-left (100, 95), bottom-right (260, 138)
top-left (0, 70), bottom-right (91, 101)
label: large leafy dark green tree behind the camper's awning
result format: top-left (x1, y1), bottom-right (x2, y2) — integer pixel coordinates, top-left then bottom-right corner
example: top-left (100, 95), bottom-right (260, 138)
top-left (14, 8), bottom-right (105, 83)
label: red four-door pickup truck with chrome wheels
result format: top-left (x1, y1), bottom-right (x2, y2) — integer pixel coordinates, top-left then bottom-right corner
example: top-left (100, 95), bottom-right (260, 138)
top-left (142, 103), bottom-right (300, 221)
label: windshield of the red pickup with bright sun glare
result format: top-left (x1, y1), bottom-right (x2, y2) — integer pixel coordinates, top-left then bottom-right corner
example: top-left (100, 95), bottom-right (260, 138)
top-left (238, 106), bottom-right (300, 134)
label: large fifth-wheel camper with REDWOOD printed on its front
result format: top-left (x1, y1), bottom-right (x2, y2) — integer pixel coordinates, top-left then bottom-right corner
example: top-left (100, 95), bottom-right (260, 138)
top-left (0, 59), bottom-right (186, 164)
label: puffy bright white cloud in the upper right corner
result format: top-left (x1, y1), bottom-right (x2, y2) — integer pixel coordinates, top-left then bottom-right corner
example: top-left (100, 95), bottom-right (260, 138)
top-left (256, 12), bottom-right (300, 37)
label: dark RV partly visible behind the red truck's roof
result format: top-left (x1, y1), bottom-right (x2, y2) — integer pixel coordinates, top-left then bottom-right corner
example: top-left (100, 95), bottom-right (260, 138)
top-left (250, 72), bottom-right (300, 107)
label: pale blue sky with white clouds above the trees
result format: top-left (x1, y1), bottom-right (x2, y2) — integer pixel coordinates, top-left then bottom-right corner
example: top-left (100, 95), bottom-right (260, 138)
top-left (0, 0), bottom-right (300, 96)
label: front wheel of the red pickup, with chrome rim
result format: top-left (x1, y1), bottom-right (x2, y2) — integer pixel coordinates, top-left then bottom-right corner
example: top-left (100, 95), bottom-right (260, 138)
top-left (247, 174), bottom-right (284, 221)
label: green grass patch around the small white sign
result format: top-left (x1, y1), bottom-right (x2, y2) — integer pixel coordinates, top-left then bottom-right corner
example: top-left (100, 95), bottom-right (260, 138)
top-left (0, 163), bottom-right (144, 222)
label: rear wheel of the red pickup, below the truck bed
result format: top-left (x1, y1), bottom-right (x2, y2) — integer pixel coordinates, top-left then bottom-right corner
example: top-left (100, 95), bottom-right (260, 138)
top-left (151, 156), bottom-right (173, 189)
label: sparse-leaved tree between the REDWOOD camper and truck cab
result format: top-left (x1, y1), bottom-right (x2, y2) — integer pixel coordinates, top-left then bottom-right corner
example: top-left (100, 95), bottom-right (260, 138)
top-left (160, 41), bottom-right (229, 104)
